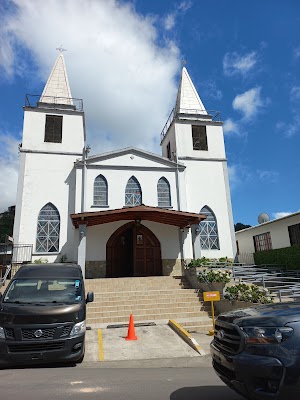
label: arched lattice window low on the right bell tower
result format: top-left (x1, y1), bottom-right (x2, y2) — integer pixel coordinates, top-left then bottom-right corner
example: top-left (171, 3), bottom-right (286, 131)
top-left (199, 206), bottom-right (220, 250)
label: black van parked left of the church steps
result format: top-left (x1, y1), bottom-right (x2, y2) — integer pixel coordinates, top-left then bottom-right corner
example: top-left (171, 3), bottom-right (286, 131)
top-left (0, 264), bottom-right (94, 367)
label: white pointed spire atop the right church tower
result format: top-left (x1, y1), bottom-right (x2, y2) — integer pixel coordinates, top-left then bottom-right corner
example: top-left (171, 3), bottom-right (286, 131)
top-left (176, 67), bottom-right (207, 114)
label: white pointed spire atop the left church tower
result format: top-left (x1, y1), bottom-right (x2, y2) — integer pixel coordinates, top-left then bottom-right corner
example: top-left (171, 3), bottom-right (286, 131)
top-left (40, 48), bottom-right (73, 105)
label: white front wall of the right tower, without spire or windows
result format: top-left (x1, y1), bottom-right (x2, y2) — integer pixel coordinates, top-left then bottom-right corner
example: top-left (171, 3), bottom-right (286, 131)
top-left (176, 122), bottom-right (236, 258)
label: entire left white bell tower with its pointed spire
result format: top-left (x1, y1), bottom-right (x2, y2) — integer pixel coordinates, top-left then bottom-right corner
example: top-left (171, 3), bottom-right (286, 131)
top-left (14, 48), bottom-right (85, 262)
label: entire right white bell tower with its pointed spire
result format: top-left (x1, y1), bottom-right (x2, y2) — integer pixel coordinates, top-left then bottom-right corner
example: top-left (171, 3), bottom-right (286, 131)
top-left (161, 67), bottom-right (235, 258)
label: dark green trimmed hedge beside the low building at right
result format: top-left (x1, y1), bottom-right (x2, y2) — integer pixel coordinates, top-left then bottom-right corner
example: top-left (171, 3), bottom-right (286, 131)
top-left (254, 245), bottom-right (300, 269)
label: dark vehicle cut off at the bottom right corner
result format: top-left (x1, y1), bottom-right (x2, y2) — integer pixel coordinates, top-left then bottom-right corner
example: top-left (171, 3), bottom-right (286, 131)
top-left (211, 302), bottom-right (300, 400)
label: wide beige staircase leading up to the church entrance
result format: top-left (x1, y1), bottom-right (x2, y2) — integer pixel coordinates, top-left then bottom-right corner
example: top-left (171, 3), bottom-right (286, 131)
top-left (85, 276), bottom-right (212, 332)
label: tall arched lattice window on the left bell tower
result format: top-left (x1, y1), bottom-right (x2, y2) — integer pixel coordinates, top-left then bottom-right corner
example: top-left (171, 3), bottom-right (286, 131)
top-left (36, 203), bottom-right (60, 253)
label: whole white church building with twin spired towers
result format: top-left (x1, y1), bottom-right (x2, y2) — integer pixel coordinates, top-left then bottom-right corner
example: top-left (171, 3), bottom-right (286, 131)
top-left (13, 53), bottom-right (236, 278)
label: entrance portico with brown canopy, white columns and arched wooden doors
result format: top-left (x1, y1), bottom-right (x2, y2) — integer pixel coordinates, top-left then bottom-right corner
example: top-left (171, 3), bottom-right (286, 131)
top-left (71, 205), bottom-right (205, 277)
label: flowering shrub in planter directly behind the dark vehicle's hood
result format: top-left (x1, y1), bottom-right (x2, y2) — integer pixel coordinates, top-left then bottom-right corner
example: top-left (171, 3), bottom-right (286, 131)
top-left (224, 283), bottom-right (273, 304)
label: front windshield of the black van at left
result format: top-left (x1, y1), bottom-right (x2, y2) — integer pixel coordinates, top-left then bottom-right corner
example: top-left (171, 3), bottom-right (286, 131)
top-left (3, 279), bottom-right (83, 303)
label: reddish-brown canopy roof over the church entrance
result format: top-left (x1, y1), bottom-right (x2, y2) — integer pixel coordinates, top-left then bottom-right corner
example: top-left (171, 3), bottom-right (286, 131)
top-left (71, 205), bottom-right (206, 228)
